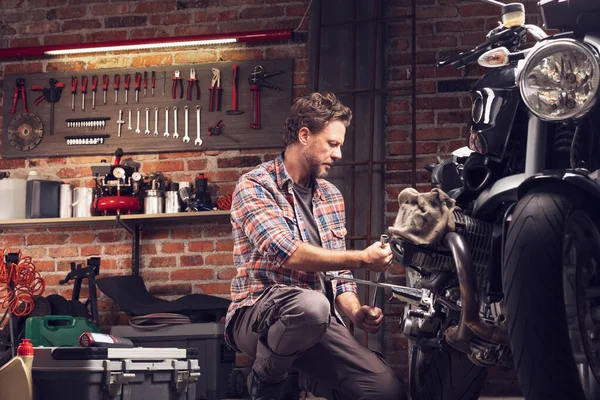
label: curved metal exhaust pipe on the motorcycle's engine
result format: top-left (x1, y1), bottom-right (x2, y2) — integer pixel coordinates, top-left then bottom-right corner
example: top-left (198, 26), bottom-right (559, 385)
top-left (443, 232), bottom-right (509, 352)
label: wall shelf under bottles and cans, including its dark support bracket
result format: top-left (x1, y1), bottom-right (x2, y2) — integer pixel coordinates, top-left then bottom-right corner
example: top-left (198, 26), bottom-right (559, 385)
top-left (0, 210), bottom-right (231, 275)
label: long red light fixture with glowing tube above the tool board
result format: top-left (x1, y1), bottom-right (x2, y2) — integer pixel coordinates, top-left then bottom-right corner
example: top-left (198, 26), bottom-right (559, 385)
top-left (0, 29), bottom-right (292, 59)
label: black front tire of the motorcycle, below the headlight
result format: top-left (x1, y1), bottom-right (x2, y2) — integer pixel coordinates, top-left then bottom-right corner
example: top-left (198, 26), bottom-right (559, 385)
top-left (502, 184), bottom-right (595, 400)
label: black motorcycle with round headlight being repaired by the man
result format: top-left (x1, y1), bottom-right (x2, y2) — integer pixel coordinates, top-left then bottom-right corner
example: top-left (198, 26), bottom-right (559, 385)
top-left (390, 0), bottom-right (600, 400)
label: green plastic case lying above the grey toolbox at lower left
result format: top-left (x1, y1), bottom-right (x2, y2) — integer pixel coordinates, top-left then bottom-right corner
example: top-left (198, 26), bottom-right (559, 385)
top-left (25, 315), bottom-right (100, 347)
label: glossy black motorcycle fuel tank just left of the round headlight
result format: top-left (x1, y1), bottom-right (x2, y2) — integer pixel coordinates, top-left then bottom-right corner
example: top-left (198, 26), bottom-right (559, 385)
top-left (469, 65), bottom-right (521, 161)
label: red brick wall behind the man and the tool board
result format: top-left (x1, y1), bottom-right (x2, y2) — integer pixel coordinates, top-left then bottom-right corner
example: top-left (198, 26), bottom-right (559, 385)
top-left (0, 0), bottom-right (538, 393)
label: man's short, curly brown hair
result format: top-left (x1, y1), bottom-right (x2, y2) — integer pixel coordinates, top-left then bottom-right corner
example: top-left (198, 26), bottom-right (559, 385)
top-left (282, 93), bottom-right (352, 146)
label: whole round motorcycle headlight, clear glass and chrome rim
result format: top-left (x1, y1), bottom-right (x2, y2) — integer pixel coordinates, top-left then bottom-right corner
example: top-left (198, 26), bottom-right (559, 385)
top-left (519, 39), bottom-right (600, 121)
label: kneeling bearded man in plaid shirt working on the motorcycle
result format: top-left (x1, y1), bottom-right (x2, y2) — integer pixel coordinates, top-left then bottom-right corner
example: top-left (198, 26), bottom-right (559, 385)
top-left (226, 93), bottom-right (406, 400)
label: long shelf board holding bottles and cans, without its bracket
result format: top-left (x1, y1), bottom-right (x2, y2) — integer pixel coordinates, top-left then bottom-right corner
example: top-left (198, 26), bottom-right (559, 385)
top-left (0, 211), bottom-right (230, 229)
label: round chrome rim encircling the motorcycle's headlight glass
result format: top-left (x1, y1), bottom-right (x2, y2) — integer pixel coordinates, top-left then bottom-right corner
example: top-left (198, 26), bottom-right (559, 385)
top-left (518, 39), bottom-right (600, 122)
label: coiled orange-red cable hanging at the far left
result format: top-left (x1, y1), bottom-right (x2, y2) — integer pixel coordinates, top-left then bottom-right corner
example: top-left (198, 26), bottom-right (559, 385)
top-left (0, 247), bottom-right (46, 317)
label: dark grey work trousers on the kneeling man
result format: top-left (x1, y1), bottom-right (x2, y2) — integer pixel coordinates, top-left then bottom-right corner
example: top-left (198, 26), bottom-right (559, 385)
top-left (229, 286), bottom-right (407, 400)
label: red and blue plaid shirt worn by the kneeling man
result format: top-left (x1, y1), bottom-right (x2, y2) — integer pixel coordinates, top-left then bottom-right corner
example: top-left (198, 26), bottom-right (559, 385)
top-left (225, 154), bottom-right (356, 332)
